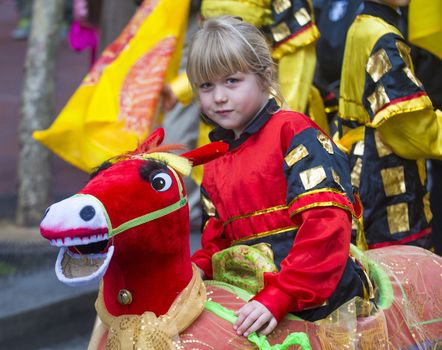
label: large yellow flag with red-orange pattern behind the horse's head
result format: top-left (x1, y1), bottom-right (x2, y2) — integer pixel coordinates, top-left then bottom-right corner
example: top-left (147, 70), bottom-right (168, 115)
top-left (33, 0), bottom-right (190, 172)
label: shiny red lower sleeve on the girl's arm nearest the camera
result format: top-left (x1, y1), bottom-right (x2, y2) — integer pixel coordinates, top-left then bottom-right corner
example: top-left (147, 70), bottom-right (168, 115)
top-left (253, 207), bottom-right (351, 321)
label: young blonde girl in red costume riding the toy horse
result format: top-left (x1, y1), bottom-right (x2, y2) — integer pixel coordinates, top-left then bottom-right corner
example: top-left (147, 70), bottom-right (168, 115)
top-left (187, 16), bottom-right (369, 336)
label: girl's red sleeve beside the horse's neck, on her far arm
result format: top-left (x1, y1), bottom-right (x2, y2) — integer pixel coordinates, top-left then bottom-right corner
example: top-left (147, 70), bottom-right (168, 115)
top-left (192, 218), bottom-right (230, 279)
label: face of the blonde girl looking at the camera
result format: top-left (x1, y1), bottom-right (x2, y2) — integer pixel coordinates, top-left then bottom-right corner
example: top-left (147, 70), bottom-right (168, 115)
top-left (198, 72), bottom-right (269, 137)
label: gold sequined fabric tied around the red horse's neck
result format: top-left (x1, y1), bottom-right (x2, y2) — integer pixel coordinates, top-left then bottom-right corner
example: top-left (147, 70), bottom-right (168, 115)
top-left (95, 266), bottom-right (206, 350)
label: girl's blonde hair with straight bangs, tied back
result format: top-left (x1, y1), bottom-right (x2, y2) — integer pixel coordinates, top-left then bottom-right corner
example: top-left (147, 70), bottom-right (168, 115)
top-left (187, 16), bottom-right (284, 104)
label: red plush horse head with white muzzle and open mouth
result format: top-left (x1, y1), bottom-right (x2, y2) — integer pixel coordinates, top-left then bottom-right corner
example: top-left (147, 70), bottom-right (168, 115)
top-left (40, 129), bottom-right (227, 315)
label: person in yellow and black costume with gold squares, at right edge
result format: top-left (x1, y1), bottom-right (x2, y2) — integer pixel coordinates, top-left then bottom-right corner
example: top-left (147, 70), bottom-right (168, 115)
top-left (338, 0), bottom-right (442, 249)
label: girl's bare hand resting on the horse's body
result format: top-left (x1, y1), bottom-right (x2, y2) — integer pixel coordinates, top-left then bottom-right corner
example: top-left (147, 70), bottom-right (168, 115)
top-left (233, 300), bottom-right (278, 337)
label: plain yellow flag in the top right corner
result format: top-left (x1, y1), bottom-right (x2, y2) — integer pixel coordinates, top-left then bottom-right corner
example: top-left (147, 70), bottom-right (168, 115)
top-left (408, 0), bottom-right (442, 59)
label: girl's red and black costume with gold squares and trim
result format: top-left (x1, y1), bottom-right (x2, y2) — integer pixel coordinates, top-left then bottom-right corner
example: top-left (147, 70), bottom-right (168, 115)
top-left (192, 100), bottom-right (367, 320)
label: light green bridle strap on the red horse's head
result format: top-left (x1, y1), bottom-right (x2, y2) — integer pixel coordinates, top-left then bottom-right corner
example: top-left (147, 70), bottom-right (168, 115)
top-left (73, 167), bottom-right (187, 238)
